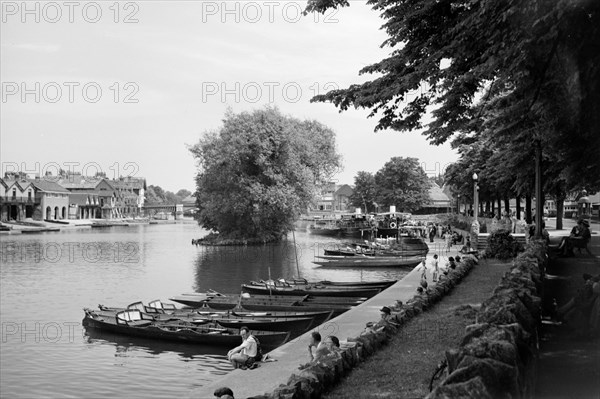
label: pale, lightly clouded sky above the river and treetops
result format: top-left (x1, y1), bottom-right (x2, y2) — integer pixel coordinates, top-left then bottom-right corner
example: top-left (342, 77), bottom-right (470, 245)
top-left (0, 1), bottom-right (457, 192)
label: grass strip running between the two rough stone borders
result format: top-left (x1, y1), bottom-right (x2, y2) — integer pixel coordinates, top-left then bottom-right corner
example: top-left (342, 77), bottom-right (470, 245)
top-left (324, 259), bottom-right (512, 399)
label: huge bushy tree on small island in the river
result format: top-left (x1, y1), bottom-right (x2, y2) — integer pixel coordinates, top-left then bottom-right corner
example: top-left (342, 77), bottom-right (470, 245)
top-left (189, 107), bottom-right (340, 243)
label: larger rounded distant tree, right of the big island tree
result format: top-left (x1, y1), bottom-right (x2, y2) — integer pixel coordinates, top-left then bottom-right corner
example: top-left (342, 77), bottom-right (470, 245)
top-left (375, 157), bottom-right (431, 212)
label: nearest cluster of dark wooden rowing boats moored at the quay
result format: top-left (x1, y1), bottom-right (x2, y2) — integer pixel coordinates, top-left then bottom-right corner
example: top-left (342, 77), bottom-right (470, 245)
top-left (83, 279), bottom-right (395, 348)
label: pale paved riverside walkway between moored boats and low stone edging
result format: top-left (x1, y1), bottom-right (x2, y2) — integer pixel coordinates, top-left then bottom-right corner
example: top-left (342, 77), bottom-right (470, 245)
top-left (197, 239), bottom-right (460, 398)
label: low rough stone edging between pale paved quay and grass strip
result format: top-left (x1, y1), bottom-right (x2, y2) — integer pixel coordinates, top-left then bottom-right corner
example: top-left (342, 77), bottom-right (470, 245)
top-left (247, 257), bottom-right (477, 399)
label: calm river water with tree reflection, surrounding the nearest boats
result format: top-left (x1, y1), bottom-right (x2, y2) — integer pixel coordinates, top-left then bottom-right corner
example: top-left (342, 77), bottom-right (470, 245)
top-left (0, 223), bottom-right (406, 398)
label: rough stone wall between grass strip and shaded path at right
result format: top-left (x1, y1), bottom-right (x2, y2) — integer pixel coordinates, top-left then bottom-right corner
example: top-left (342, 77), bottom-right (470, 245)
top-left (427, 241), bottom-right (547, 399)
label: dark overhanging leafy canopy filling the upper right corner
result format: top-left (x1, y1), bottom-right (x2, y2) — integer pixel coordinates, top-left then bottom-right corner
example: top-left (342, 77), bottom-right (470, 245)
top-left (307, 0), bottom-right (600, 197)
